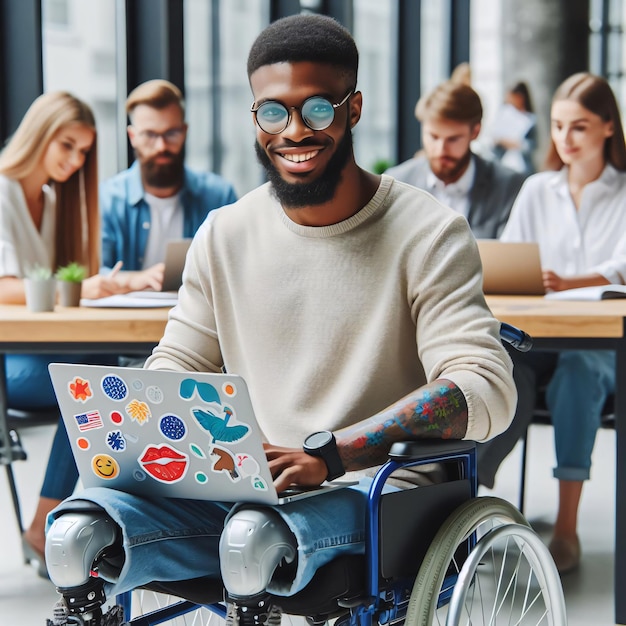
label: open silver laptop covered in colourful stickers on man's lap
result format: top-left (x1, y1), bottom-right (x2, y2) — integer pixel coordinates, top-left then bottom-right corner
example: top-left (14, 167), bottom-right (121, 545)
top-left (49, 363), bottom-right (355, 504)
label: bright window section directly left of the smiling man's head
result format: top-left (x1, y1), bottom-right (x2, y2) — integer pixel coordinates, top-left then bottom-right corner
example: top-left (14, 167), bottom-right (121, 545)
top-left (184, 0), bottom-right (269, 195)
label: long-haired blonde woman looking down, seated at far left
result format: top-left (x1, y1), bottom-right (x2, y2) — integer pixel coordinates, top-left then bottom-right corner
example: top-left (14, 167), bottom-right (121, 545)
top-left (0, 92), bottom-right (123, 573)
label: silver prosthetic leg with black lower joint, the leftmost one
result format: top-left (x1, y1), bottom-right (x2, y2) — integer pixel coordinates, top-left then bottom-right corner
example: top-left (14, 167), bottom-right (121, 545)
top-left (46, 502), bottom-right (124, 626)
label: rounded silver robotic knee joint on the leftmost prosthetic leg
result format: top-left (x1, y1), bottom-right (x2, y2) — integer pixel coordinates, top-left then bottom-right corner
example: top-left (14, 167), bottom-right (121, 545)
top-left (46, 509), bottom-right (123, 613)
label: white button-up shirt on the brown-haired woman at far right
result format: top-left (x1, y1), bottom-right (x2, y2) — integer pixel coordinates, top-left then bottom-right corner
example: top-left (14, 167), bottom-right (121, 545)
top-left (500, 165), bottom-right (626, 284)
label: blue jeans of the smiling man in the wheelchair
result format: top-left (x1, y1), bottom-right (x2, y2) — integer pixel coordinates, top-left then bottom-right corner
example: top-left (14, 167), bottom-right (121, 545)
top-left (48, 478), bottom-right (376, 598)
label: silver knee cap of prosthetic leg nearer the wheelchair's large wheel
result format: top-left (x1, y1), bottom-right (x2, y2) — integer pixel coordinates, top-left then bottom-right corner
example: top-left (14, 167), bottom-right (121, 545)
top-left (220, 508), bottom-right (297, 598)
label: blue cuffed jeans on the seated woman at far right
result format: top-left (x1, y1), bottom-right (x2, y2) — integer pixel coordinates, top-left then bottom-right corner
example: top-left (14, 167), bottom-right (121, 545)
top-left (546, 350), bottom-right (615, 481)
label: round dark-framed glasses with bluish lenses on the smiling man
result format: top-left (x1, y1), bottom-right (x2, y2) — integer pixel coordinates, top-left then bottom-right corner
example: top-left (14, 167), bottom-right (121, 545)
top-left (250, 89), bottom-right (354, 135)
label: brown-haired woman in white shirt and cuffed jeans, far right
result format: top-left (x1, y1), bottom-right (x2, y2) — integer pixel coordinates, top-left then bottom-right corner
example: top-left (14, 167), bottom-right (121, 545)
top-left (482, 73), bottom-right (626, 573)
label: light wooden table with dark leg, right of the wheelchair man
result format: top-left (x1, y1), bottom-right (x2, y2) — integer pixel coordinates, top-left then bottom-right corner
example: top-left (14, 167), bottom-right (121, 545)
top-left (487, 296), bottom-right (626, 624)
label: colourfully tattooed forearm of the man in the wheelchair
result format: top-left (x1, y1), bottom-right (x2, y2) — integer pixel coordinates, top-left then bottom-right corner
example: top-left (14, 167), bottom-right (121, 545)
top-left (335, 380), bottom-right (467, 470)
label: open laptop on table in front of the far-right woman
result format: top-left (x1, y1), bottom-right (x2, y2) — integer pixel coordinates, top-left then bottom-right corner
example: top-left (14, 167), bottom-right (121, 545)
top-left (477, 239), bottom-right (545, 296)
